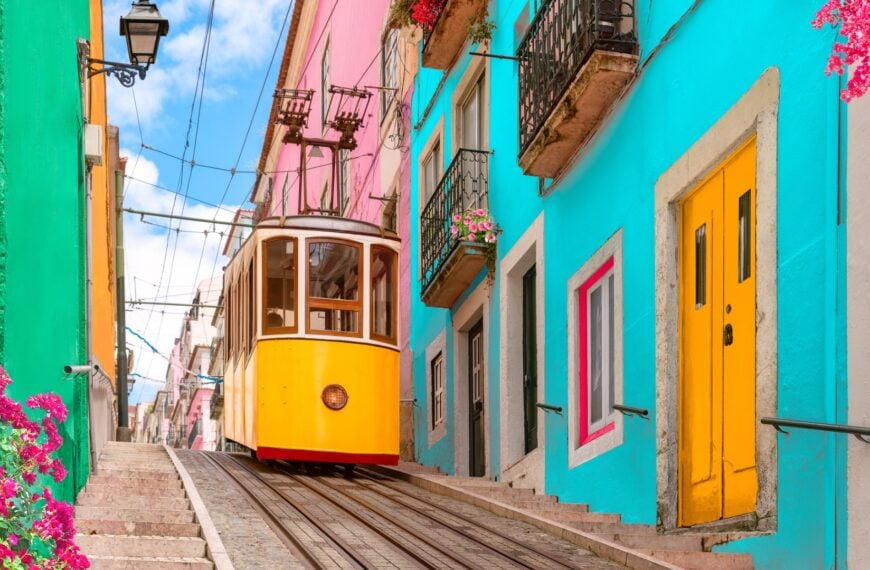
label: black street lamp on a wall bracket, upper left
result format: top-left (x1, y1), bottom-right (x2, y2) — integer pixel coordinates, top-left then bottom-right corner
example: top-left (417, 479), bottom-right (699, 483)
top-left (87, 0), bottom-right (169, 87)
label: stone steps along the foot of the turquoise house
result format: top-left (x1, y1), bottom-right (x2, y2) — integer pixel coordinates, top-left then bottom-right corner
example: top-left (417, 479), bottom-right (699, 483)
top-left (382, 464), bottom-right (754, 570)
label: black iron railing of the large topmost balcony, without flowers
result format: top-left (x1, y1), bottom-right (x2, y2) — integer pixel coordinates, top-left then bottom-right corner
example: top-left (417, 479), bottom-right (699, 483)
top-left (517, 0), bottom-right (637, 155)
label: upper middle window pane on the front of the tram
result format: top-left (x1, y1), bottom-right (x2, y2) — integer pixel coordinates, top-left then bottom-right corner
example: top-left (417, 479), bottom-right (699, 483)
top-left (308, 242), bottom-right (359, 300)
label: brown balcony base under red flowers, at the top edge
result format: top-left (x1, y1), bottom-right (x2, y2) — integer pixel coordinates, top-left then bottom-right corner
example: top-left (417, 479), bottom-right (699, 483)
top-left (423, 0), bottom-right (487, 69)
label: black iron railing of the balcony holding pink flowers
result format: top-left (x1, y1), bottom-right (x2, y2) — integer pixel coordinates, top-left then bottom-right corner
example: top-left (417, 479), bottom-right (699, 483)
top-left (420, 148), bottom-right (489, 291)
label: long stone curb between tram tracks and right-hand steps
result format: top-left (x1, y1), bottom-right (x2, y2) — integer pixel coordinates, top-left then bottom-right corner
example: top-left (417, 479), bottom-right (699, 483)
top-left (368, 465), bottom-right (683, 570)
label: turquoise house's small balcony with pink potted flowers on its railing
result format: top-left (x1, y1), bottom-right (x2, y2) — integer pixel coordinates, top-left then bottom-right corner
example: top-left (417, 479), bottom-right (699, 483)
top-left (420, 149), bottom-right (490, 308)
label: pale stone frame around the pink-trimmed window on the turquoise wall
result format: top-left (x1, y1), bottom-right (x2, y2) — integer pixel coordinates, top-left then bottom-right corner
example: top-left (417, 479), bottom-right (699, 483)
top-left (567, 229), bottom-right (624, 469)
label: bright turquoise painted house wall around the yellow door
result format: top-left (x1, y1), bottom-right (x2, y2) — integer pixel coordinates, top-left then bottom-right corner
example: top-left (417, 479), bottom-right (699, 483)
top-left (410, 0), bottom-right (846, 568)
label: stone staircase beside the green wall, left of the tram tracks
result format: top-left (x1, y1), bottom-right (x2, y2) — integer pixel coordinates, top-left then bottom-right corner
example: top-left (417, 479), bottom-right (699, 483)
top-left (75, 442), bottom-right (214, 570)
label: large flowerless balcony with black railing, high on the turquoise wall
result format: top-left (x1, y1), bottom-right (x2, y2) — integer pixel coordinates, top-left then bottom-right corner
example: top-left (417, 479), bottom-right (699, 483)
top-left (517, 0), bottom-right (638, 178)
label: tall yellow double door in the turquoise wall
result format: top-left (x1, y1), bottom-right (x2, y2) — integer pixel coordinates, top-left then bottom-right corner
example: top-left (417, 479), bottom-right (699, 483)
top-left (678, 139), bottom-right (758, 526)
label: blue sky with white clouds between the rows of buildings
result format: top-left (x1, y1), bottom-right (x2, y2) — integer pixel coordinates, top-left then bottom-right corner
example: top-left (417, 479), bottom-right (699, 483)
top-left (103, 0), bottom-right (293, 404)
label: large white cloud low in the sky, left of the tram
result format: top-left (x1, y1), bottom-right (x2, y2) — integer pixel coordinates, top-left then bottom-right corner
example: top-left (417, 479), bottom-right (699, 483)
top-left (121, 150), bottom-right (237, 403)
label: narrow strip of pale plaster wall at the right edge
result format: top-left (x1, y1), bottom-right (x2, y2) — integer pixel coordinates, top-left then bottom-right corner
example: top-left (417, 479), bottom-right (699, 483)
top-left (846, 76), bottom-right (870, 568)
